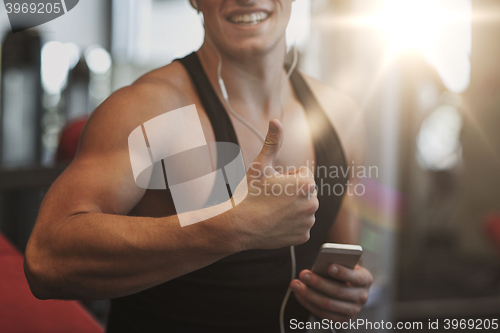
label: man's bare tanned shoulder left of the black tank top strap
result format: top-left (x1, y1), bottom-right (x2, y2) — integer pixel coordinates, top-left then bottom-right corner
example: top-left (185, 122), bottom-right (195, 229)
top-left (81, 63), bottom-right (192, 154)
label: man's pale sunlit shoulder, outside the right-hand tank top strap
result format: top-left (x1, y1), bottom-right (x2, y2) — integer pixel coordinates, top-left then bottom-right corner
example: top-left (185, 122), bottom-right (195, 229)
top-left (301, 73), bottom-right (366, 165)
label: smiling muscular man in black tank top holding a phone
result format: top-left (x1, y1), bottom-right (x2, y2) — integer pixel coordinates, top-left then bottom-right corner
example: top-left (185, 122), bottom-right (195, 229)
top-left (25, 0), bottom-right (372, 332)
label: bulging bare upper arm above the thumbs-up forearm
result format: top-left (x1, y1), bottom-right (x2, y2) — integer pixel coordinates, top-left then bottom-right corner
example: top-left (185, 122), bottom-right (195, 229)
top-left (37, 87), bottom-right (151, 223)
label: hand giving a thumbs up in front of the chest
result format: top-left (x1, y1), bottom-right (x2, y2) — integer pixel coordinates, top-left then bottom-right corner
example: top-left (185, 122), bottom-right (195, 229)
top-left (234, 119), bottom-right (319, 249)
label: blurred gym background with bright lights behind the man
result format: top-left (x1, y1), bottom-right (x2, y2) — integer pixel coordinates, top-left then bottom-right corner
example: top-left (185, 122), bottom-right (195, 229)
top-left (0, 0), bottom-right (500, 332)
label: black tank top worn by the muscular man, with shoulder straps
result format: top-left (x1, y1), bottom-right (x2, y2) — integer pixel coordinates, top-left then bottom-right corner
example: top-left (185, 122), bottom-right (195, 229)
top-left (107, 53), bottom-right (347, 333)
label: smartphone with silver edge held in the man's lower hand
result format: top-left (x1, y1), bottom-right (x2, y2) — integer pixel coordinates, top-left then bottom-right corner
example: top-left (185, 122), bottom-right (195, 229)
top-left (312, 243), bottom-right (363, 279)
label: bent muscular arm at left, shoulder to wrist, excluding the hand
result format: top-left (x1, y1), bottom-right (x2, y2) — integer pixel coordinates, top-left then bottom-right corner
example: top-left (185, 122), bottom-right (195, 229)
top-left (25, 82), bottom-right (241, 299)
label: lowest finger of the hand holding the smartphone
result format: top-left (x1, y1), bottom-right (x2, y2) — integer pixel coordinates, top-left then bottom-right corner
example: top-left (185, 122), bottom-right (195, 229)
top-left (291, 280), bottom-right (361, 318)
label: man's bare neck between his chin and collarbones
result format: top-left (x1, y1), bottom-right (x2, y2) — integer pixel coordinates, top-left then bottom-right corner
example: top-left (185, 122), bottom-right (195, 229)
top-left (198, 40), bottom-right (287, 119)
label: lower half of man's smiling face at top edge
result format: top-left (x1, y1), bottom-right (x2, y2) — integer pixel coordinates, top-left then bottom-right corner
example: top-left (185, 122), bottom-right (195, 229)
top-left (192, 0), bottom-right (292, 57)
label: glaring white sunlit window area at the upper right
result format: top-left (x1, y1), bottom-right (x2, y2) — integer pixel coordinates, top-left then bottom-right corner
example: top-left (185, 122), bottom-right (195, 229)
top-left (370, 0), bottom-right (472, 93)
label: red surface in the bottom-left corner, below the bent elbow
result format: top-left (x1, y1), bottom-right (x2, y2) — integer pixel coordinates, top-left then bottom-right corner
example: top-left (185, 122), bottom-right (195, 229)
top-left (0, 234), bottom-right (104, 333)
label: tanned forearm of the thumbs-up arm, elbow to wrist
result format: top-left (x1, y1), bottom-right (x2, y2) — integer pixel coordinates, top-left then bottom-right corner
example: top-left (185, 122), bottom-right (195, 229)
top-left (25, 211), bottom-right (241, 299)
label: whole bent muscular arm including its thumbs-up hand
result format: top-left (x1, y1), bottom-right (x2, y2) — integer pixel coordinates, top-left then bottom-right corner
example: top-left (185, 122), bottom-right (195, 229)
top-left (25, 78), bottom-right (318, 299)
